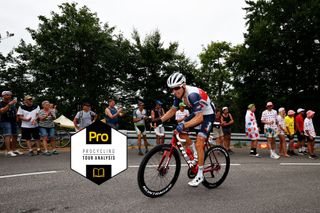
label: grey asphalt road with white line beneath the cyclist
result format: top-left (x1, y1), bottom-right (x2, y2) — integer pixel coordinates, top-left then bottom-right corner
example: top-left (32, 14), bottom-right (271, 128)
top-left (0, 148), bottom-right (320, 213)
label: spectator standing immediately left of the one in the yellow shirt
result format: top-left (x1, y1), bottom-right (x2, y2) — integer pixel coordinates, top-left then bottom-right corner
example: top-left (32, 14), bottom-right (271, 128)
top-left (277, 107), bottom-right (290, 157)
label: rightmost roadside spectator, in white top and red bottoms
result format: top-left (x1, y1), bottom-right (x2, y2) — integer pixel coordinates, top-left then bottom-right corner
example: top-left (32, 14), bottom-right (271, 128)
top-left (304, 110), bottom-right (318, 159)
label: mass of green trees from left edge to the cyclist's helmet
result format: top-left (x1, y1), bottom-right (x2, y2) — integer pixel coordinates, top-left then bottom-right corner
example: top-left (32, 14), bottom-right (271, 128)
top-left (0, 3), bottom-right (195, 128)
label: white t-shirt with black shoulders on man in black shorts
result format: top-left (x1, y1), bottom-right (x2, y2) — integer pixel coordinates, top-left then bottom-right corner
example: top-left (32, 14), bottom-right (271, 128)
top-left (17, 105), bottom-right (40, 128)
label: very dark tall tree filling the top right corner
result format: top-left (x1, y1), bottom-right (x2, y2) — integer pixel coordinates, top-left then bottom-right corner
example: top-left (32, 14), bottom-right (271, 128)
top-left (230, 0), bottom-right (320, 131)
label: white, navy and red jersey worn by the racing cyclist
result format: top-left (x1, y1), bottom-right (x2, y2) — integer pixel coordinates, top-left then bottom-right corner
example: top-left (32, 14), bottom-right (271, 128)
top-left (173, 86), bottom-right (215, 115)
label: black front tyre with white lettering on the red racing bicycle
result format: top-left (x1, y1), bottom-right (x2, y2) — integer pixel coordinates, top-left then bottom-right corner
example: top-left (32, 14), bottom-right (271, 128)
top-left (138, 144), bottom-right (181, 198)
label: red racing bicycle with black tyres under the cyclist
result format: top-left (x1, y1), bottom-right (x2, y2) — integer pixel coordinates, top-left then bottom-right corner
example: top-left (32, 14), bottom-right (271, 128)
top-left (138, 131), bottom-right (230, 198)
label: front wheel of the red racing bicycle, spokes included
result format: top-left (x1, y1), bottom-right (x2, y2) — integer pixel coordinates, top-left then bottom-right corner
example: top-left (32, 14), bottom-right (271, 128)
top-left (138, 144), bottom-right (181, 198)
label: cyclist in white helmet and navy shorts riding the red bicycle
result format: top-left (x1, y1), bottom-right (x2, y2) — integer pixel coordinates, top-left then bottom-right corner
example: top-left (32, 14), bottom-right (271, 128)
top-left (154, 72), bottom-right (215, 186)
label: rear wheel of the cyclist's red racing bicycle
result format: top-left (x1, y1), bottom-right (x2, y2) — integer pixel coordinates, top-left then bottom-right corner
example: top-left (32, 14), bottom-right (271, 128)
top-left (202, 145), bottom-right (230, 189)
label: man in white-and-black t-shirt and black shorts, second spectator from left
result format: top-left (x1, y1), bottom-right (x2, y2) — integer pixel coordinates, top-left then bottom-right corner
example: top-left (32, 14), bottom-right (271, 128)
top-left (17, 95), bottom-right (41, 156)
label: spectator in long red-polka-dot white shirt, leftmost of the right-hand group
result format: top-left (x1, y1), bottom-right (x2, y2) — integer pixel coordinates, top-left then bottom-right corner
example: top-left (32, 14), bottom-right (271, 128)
top-left (245, 104), bottom-right (261, 158)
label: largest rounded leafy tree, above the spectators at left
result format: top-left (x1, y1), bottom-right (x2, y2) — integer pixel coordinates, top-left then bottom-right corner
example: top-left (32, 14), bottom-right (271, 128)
top-left (17, 3), bottom-right (128, 114)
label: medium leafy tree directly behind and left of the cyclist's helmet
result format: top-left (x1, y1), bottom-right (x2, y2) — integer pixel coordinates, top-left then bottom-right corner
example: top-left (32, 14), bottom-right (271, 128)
top-left (129, 31), bottom-right (195, 111)
